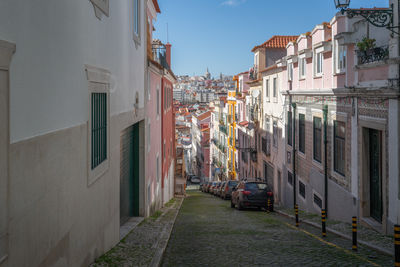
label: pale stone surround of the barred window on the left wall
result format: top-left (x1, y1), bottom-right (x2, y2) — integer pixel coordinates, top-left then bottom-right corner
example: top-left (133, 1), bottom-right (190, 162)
top-left (85, 65), bottom-right (111, 186)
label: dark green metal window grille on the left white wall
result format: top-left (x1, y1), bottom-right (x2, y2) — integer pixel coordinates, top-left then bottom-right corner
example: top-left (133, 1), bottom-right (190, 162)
top-left (91, 93), bottom-right (107, 170)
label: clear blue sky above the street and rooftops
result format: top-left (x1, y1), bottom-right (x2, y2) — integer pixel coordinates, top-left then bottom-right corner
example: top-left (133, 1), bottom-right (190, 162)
top-left (154, 0), bottom-right (389, 76)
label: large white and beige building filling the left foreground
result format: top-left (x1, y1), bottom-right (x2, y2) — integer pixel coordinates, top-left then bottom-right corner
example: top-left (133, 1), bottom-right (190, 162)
top-left (0, 0), bottom-right (147, 267)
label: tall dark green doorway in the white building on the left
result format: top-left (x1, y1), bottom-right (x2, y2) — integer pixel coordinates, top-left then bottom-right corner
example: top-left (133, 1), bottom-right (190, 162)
top-left (120, 124), bottom-right (139, 225)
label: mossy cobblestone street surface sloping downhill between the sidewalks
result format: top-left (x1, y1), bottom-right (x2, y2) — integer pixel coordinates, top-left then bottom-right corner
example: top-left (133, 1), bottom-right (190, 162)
top-left (162, 191), bottom-right (394, 266)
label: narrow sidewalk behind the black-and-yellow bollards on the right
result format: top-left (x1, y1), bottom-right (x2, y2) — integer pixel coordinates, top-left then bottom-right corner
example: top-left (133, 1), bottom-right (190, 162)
top-left (275, 207), bottom-right (394, 256)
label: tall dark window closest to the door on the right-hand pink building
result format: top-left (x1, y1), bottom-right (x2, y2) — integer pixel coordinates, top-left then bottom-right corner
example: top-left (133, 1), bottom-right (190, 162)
top-left (333, 121), bottom-right (346, 175)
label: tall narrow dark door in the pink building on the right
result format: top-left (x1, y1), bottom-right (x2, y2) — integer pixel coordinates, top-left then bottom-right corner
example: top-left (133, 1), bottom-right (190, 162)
top-left (369, 129), bottom-right (382, 222)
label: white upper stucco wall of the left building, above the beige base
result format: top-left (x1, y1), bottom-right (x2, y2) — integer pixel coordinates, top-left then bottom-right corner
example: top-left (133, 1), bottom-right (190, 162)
top-left (0, 0), bottom-right (146, 143)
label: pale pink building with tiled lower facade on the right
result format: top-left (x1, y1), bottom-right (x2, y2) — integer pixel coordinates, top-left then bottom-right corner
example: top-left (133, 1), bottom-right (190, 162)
top-left (278, 13), bottom-right (398, 232)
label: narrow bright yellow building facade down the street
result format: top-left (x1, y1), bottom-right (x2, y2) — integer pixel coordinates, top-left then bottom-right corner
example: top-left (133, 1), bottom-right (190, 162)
top-left (227, 76), bottom-right (239, 180)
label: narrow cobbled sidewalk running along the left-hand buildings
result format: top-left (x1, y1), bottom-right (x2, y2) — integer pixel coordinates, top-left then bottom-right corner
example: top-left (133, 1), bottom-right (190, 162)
top-left (90, 198), bottom-right (183, 267)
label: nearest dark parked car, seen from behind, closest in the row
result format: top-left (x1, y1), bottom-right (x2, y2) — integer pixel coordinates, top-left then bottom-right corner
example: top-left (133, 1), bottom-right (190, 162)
top-left (231, 181), bottom-right (274, 211)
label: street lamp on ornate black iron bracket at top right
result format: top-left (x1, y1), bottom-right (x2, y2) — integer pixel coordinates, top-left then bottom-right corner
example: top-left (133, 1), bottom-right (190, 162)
top-left (334, 0), bottom-right (399, 34)
